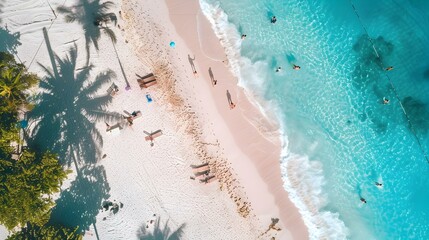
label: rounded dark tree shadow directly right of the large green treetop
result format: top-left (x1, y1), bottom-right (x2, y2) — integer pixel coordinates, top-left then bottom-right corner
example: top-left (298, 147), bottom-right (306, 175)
top-left (49, 165), bottom-right (110, 233)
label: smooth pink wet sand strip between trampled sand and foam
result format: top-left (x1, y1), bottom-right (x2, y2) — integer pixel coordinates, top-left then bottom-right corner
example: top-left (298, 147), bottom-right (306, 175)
top-left (165, 0), bottom-right (308, 239)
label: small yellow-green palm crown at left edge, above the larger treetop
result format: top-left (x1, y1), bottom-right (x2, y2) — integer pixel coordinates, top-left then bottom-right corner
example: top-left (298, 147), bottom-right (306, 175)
top-left (0, 53), bottom-right (39, 114)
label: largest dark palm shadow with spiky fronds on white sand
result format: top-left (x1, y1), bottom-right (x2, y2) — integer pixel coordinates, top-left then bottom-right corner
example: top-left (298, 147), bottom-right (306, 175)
top-left (28, 42), bottom-right (121, 169)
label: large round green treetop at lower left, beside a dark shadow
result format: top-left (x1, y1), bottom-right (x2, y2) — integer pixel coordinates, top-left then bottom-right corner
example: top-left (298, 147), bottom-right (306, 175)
top-left (0, 151), bottom-right (70, 229)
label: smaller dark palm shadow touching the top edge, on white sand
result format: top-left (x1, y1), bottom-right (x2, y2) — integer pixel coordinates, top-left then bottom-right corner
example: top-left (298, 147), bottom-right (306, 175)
top-left (57, 0), bottom-right (117, 64)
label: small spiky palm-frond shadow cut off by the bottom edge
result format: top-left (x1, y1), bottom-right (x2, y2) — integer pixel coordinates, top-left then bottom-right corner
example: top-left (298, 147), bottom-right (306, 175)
top-left (137, 217), bottom-right (186, 240)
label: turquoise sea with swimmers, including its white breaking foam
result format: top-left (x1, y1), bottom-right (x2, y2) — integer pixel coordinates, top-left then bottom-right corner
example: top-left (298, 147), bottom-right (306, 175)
top-left (200, 0), bottom-right (429, 239)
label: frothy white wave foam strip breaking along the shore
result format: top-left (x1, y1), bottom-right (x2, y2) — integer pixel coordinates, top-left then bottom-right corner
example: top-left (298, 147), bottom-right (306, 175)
top-left (200, 0), bottom-right (348, 239)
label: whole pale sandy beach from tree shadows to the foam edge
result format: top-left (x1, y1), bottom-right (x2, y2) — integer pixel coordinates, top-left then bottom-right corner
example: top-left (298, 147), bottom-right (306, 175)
top-left (0, 0), bottom-right (308, 239)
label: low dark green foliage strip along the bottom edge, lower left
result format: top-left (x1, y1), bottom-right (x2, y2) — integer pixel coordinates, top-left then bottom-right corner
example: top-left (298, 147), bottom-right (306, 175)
top-left (6, 224), bottom-right (82, 240)
